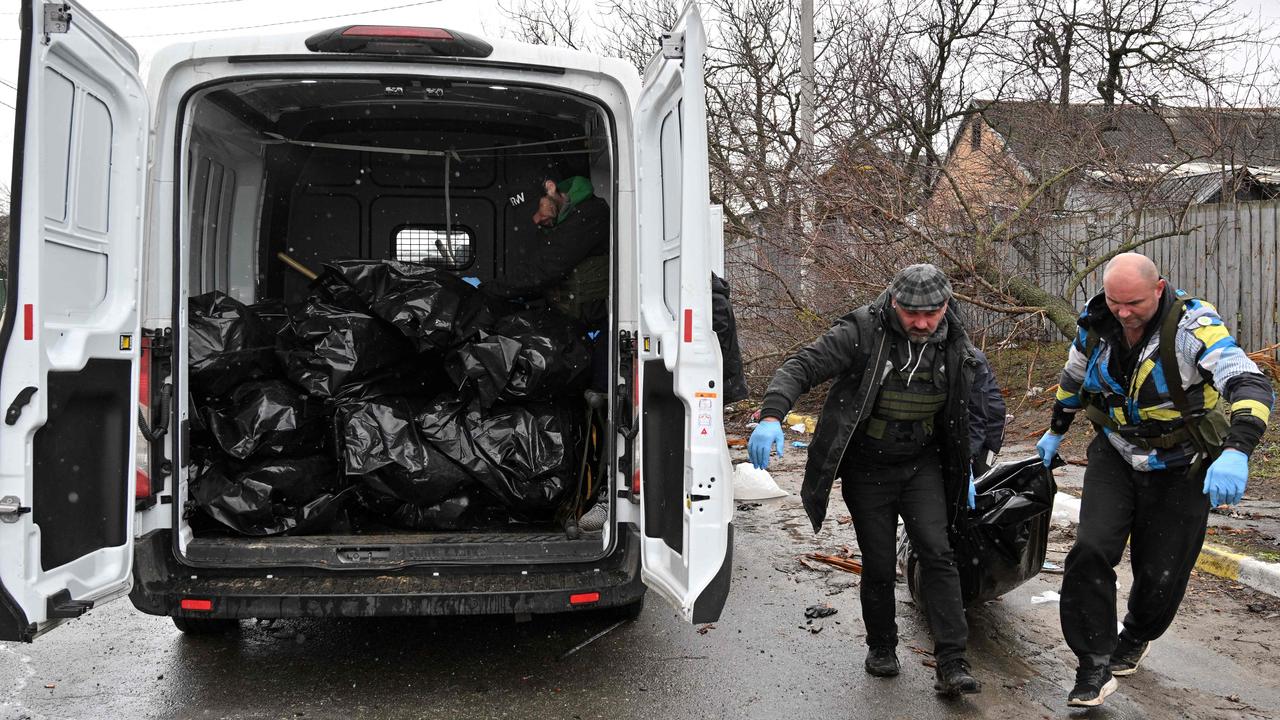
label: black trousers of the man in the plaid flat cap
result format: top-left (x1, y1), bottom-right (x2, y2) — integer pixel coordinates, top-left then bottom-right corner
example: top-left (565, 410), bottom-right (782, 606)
top-left (840, 448), bottom-right (969, 662)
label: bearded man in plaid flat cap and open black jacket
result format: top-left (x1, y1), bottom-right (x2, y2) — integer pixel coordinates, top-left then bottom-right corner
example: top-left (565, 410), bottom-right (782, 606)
top-left (748, 264), bottom-right (982, 697)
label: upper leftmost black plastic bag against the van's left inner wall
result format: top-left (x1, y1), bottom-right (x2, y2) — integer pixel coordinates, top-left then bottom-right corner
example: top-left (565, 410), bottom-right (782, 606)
top-left (187, 292), bottom-right (279, 397)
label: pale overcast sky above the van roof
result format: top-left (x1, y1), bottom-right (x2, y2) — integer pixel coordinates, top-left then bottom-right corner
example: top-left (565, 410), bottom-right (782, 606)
top-left (0, 0), bottom-right (1280, 202)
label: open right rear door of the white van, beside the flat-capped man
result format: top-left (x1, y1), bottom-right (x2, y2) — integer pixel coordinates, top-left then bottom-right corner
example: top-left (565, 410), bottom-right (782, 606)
top-left (636, 3), bottom-right (733, 623)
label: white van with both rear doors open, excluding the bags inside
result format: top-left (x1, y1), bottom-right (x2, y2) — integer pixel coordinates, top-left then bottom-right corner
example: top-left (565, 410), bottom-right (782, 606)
top-left (0, 0), bottom-right (732, 641)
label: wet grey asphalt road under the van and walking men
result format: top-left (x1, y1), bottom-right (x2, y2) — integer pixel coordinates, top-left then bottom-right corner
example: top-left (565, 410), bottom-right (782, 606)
top-left (0, 448), bottom-right (1280, 720)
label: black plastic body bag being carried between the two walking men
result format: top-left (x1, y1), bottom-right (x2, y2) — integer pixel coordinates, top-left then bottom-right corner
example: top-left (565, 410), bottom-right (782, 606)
top-left (899, 456), bottom-right (1061, 607)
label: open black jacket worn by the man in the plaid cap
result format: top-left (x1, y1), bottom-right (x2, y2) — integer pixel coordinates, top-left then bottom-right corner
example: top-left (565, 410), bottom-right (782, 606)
top-left (760, 292), bottom-right (978, 533)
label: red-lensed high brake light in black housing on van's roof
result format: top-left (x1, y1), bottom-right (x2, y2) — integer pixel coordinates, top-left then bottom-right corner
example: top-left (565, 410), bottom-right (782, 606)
top-left (306, 26), bottom-right (493, 58)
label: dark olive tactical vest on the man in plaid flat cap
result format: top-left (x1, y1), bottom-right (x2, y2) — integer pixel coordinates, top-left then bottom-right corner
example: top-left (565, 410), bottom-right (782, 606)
top-left (854, 350), bottom-right (947, 457)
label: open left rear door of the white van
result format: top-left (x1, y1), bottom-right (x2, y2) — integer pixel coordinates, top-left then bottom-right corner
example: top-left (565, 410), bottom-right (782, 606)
top-left (0, 0), bottom-right (147, 641)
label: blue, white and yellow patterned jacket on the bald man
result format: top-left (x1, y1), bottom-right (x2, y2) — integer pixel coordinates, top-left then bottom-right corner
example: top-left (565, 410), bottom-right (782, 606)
top-left (1050, 283), bottom-right (1274, 470)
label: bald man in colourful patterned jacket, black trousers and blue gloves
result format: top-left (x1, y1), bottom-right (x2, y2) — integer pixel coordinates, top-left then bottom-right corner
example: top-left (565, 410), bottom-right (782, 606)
top-left (1036, 252), bottom-right (1272, 707)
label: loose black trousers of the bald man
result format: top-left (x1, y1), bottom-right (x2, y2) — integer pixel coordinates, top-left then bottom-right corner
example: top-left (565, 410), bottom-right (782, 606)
top-left (1060, 434), bottom-right (1210, 665)
